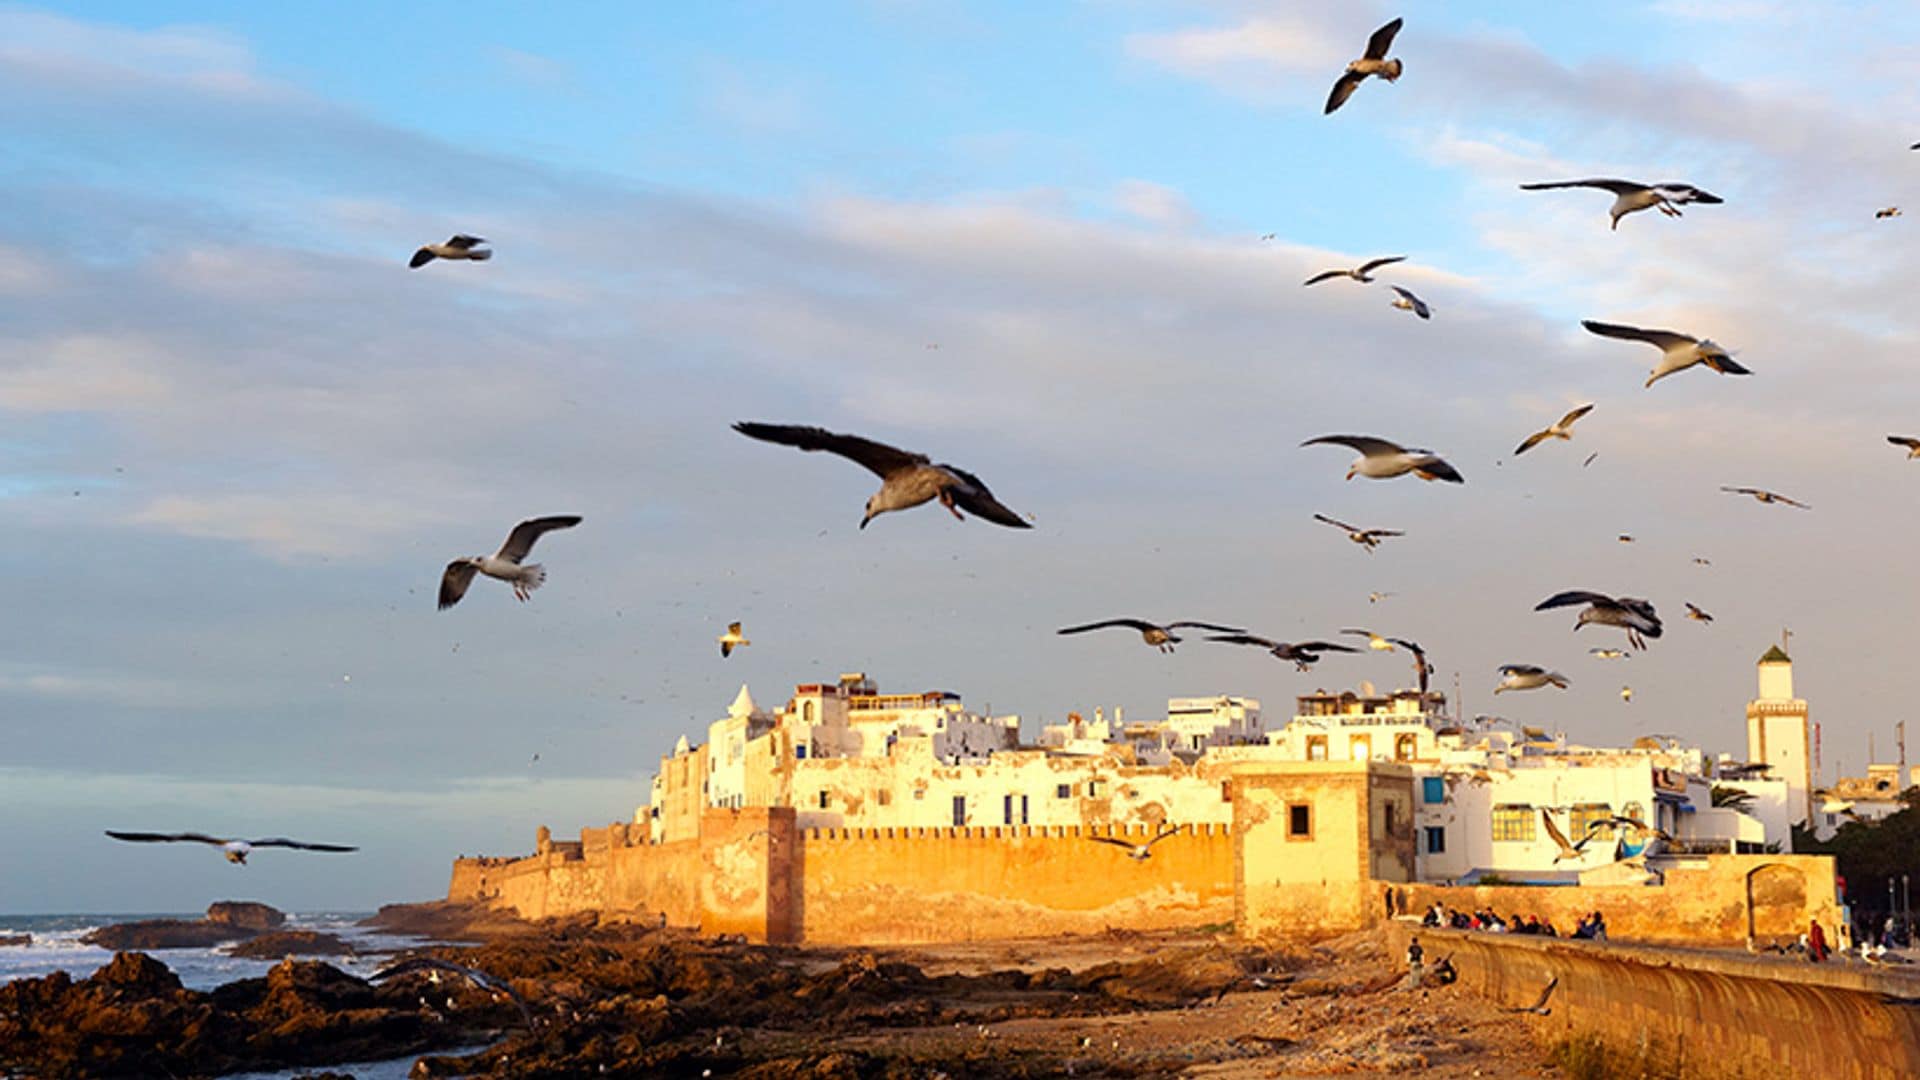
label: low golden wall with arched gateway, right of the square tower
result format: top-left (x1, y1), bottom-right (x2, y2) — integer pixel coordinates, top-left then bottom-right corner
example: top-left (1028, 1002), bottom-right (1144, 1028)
top-left (1394, 855), bottom-right (1839, 947)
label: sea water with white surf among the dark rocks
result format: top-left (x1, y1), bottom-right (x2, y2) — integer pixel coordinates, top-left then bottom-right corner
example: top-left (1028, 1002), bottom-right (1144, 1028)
top-left (0, 911), bottom-right (482, 1080)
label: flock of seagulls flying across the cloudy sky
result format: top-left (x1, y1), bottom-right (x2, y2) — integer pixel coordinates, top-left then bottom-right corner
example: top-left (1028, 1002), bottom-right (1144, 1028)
top-left (108, 19), bottom-right (1920, 865)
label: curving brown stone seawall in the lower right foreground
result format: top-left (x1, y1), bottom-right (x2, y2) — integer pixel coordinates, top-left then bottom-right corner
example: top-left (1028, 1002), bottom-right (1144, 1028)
top-left (1388, 920), bottom-right (1920, 1080)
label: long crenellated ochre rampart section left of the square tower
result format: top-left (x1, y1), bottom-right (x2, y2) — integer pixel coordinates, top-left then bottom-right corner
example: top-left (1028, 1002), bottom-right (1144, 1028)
top-left (791, 824), bottom-right (1233, 944)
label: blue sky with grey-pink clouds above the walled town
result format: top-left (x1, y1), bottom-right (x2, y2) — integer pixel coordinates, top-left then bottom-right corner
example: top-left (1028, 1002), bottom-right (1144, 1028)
top-left (0, 0), bottom-right (1920, 911)
